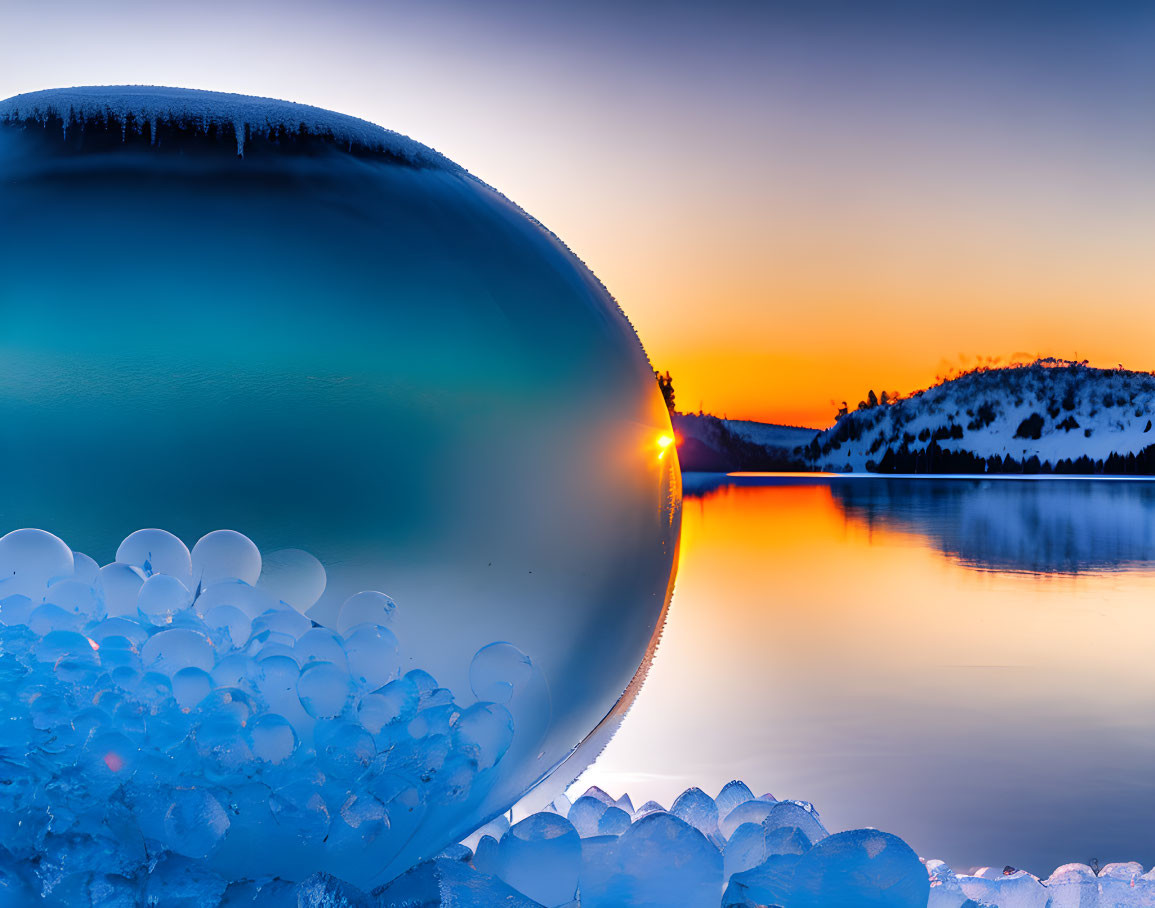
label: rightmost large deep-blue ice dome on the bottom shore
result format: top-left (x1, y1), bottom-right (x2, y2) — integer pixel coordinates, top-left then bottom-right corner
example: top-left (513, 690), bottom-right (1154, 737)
top-left (778, 829), bottom-right (924, 908)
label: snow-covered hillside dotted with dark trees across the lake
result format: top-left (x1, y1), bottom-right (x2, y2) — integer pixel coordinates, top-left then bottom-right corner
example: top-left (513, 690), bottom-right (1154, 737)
top-left (798, 360), bottom-right (1155, 474)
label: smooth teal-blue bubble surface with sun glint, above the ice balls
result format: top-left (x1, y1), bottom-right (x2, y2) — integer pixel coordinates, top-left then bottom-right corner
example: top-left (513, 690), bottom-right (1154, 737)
top-left (0, 88), bottom-right (680, 882)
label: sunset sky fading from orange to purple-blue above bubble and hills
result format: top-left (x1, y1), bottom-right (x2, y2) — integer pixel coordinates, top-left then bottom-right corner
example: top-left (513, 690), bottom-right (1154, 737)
top-left (0, 0), bottom-right (1155, 426)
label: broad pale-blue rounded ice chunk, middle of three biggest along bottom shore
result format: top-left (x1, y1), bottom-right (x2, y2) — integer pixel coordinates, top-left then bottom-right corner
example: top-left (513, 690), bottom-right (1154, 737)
top-left (582, 813), bottom-right (720, 908)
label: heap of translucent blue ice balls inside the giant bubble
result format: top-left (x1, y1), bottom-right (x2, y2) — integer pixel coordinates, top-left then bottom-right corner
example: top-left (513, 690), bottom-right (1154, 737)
top-left (0, 529), bottom-right (531, 906)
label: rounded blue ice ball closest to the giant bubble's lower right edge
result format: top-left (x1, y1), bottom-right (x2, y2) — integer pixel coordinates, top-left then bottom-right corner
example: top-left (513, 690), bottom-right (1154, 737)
top-left (498, 813), bottom-right (582, 906)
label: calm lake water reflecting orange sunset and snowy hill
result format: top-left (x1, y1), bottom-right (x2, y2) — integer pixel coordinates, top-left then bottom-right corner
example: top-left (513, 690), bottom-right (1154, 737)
top-left (578, 475), bottom-right (1155, 876)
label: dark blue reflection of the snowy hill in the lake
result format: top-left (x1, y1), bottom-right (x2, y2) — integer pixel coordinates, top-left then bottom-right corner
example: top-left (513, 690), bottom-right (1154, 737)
top-left (830, 479), bottom-right (1155, 573)
